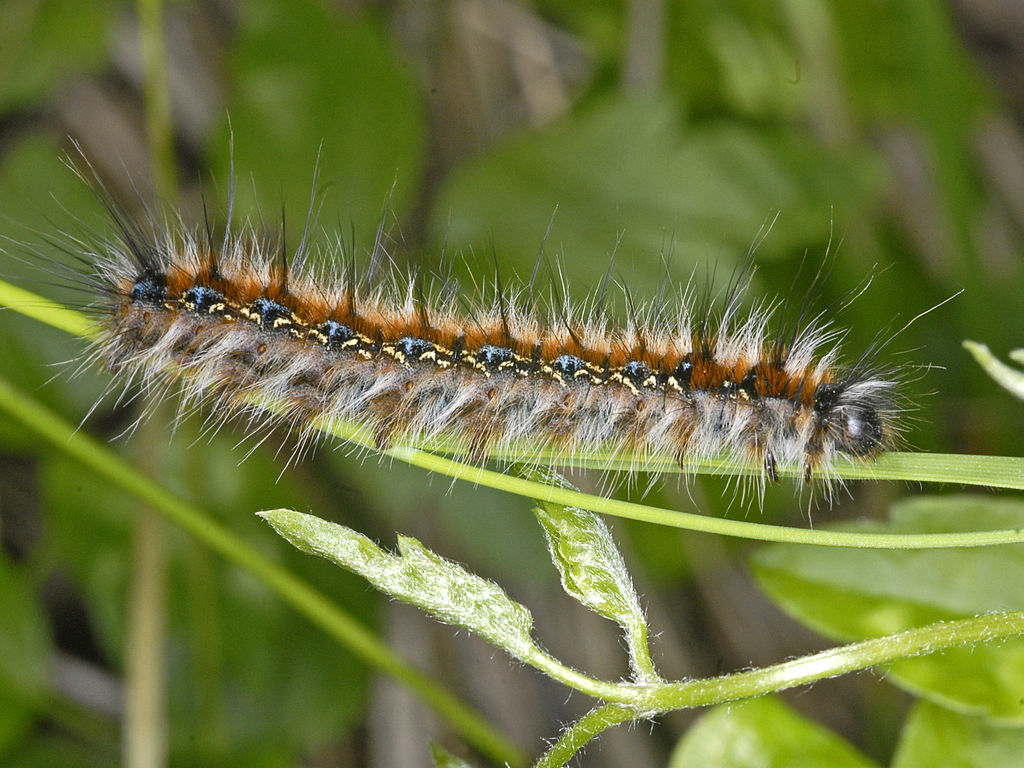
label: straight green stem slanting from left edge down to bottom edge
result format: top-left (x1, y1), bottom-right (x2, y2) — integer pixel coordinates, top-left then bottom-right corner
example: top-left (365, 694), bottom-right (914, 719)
top-left (0, 377), bottom-right (525, 766)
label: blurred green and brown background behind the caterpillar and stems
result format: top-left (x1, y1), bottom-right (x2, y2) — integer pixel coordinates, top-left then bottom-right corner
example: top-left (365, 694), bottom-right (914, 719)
top-left (0, 0), bottom-right (1024, 766)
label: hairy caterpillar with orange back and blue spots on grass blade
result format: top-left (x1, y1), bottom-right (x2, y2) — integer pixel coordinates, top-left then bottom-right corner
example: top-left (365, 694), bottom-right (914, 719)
top-left (24, 159), bottom-right (905, 501)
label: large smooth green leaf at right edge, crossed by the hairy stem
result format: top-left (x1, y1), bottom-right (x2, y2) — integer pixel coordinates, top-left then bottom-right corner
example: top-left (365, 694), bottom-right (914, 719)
top-left (754, 496), bottom-right (1024, 723)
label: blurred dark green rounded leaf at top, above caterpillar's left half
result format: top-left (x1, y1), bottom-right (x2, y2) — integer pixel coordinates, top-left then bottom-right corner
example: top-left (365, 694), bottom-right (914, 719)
top-left (211, 0), bottom-right (426, 242)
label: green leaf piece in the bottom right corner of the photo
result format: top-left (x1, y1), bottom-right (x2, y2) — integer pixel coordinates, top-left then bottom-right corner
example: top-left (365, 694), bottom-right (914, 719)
top-left (892, 701), bottom-right (1024, 768)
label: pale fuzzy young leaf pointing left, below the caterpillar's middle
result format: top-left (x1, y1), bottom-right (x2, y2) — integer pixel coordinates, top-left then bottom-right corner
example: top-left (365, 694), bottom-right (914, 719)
top-left (259, 509), bottom-right (539, 658)
